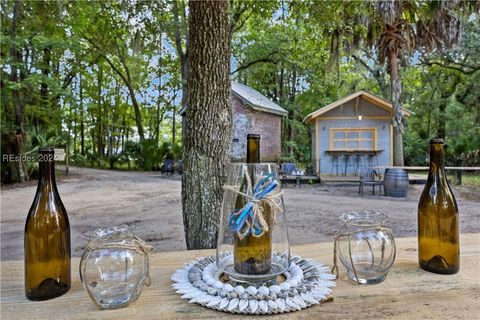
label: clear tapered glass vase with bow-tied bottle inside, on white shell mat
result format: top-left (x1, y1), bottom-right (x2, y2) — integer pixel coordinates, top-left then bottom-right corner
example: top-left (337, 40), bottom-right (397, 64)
top-left (217, 163), bottom-right (290, 284)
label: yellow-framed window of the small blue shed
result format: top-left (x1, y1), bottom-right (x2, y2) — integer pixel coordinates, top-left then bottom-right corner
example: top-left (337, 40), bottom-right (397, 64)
top-left (330, 128), bottom-right (377, 150)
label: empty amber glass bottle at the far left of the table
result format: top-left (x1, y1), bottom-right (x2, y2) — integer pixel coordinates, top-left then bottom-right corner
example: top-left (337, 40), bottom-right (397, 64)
top-left (24, 148), bottom-right (71, 300)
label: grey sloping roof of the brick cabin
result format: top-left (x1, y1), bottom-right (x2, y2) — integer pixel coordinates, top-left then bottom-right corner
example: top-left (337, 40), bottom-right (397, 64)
top-left (232, 82), bottom-right (288, 116)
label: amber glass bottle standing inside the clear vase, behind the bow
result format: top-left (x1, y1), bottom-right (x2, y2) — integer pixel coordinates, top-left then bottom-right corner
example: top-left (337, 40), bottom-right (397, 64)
top-left (233, 134), bottom-right (274, 274)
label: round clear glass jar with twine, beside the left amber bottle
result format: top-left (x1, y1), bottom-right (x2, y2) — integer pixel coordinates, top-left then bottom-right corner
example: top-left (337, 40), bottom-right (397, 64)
top-left (80, 226), bottom-right (152, 309)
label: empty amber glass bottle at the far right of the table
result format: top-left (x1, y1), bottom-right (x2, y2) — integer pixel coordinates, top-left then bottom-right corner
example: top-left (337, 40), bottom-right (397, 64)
top-left (418, 139), bottom-right (460, 274)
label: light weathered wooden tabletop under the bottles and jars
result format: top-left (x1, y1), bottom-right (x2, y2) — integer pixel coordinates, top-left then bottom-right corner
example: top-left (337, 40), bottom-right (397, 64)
top-left (1, 234), bottom-right (480, 320)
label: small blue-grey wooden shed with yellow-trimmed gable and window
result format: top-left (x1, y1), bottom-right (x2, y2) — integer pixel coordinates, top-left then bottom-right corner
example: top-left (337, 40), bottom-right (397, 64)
top-left (304, 90), bottom-right (412, 175)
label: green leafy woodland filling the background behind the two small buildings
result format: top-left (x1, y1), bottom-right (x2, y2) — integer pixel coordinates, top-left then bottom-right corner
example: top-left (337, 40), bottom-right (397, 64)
top-left (0, 0), bottom-right (480, 183)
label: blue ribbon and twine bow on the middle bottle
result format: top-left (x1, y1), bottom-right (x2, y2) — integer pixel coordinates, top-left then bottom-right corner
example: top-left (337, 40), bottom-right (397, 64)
top-left (223, 167), bottom-right (282, 240)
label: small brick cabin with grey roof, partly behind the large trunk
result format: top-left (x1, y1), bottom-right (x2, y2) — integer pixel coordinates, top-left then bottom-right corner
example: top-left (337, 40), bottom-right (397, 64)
top-left (180, 82), bottom-right (288, 162)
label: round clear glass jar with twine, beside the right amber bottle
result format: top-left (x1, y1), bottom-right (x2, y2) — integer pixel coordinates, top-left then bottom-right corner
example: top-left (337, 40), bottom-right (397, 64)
top-left (334, 211), bottom-right (396, 284)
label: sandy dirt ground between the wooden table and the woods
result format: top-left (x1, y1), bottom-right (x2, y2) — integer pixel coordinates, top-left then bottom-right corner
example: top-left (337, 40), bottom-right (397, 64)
top-left (1, 168), bottom-right (480, 260)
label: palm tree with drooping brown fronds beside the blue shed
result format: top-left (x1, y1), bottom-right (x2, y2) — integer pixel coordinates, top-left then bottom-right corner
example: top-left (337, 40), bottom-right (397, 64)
top-left (366, 0), bottom-right (474, 166)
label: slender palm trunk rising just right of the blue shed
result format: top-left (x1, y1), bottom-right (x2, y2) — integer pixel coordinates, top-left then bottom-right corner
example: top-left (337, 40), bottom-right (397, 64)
top-left (388, 50), bottom-right (404, 166)
